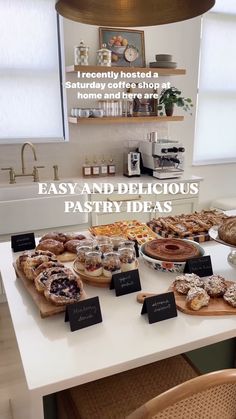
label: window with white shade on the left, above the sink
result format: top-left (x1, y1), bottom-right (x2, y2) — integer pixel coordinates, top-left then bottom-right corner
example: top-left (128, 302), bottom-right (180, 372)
top-left (0, 0), bottom-right (66, 144)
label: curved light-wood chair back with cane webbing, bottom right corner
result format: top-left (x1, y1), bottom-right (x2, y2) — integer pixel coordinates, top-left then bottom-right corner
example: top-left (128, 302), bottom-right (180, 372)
top-left (127, 369), bottom-right (236, 419)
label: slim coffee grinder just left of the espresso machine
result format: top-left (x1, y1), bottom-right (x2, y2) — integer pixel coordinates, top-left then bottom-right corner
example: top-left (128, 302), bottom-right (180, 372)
top-left (123, 141), bottom-right (141, 177)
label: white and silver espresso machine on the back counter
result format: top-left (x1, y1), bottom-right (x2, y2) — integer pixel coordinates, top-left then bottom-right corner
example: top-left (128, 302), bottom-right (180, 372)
top-left (139, 137), bottom-right (185, 179)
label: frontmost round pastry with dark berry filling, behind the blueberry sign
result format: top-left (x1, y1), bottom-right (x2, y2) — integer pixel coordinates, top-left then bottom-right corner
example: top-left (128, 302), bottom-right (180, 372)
top-left (44, 272), bottom-right (83, 305)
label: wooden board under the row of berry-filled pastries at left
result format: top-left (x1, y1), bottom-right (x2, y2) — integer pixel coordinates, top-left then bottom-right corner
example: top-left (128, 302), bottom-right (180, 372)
top-left (13, 263), bottom-right (86, 319)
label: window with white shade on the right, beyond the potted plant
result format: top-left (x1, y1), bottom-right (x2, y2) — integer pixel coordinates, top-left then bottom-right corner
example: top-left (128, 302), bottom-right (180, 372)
top-left (193, 0), bottom-right (236, 164)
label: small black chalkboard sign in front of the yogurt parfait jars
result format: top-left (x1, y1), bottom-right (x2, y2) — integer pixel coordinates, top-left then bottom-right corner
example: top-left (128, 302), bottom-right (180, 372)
top-left (110, 269), bottom-right (142, 297)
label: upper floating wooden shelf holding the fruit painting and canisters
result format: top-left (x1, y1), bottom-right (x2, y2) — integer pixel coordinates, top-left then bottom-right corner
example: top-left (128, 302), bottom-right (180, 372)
top-left (66, 65), bottom-right (186, 76)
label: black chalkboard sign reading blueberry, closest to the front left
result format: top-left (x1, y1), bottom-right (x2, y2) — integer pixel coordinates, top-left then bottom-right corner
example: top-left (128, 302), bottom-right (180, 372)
top-left (65, 297), bottom-right (102, 332)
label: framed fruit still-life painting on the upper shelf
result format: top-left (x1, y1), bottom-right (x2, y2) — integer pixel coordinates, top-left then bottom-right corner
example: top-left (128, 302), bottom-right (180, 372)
top-left (99, 28), bottom-right (146, 67)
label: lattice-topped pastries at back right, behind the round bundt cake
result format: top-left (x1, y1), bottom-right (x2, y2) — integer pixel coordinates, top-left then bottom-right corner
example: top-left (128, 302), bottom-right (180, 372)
top-left (148, 210), bottom-right (229, 241)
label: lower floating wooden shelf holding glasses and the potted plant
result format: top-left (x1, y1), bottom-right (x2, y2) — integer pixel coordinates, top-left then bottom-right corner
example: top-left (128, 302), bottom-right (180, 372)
top-left (68, 116), bottom-right (184, 125)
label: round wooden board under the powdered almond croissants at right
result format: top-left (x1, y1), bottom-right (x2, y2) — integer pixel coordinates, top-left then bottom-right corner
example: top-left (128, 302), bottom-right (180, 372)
top-left (168, 281), bottom-right (236, 316)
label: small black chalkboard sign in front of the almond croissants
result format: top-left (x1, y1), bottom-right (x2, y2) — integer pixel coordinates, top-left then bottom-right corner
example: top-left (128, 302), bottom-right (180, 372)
top-left (141, 292), bottom-right (177, 324)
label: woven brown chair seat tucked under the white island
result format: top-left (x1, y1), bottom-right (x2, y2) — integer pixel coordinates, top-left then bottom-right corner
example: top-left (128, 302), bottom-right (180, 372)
top-left (57, 355), bottom-right (199, 419)
